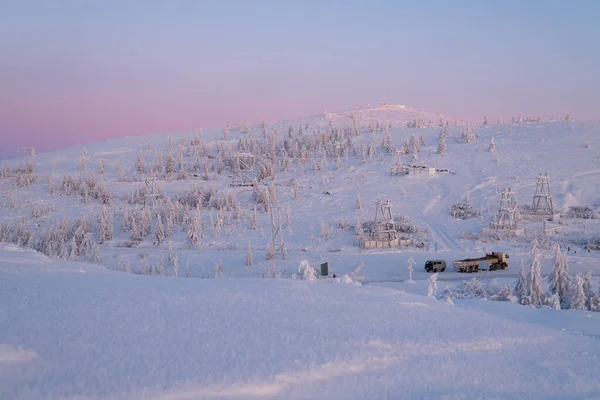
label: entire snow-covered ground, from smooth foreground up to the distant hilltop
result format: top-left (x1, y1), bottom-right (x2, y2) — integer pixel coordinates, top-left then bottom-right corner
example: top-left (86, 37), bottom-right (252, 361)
top-left (0, 105), bottom-right (600, 399)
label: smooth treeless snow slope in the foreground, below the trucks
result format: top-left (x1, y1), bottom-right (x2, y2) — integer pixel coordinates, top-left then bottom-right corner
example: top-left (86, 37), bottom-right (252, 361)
top-left (0, 245), bottom-right (600, 400)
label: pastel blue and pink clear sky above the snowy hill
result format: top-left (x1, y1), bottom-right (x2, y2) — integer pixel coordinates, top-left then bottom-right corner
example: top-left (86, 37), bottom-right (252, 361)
top-left (0, 0), bottom-right (600, 155)
